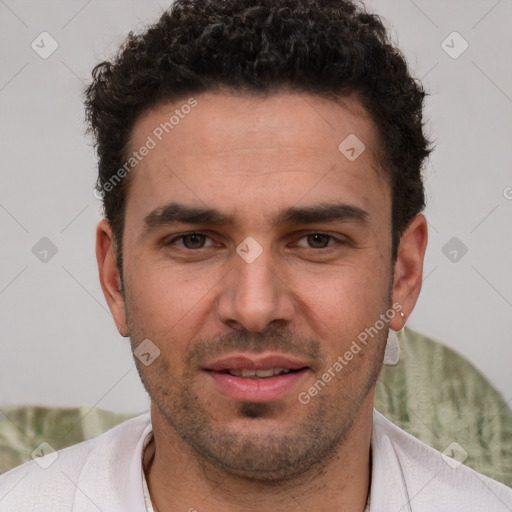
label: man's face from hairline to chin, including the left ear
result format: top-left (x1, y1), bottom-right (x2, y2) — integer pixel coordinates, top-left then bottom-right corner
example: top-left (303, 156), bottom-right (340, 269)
top-left (98, 93), bottom-right (424, 480)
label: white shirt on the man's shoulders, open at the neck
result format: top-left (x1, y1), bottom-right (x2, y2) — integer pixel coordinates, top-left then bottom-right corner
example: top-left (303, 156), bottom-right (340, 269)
top-left (0, 410), bottom-right (512, 512)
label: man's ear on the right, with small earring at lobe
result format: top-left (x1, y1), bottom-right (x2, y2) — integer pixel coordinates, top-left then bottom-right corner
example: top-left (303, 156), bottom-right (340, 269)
top-left (389, 215), bottom-right (428, 331)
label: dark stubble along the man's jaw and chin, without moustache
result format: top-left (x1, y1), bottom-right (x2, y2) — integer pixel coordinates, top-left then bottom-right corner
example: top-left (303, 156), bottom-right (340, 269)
top-left (130, 330), bottom-right (385, 484)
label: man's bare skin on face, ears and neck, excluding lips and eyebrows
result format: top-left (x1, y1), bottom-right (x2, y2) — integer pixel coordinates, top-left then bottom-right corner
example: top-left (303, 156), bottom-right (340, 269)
top-left (97, 92), bottom-right (427, 512)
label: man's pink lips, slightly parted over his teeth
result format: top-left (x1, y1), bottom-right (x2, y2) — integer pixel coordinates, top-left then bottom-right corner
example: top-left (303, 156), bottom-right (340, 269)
top-left (203, 354), bottom-right (311, 403)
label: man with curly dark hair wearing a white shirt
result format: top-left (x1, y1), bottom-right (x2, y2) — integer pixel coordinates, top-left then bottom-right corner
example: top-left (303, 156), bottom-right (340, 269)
top-left (0, 0), bottom-right (512, 512)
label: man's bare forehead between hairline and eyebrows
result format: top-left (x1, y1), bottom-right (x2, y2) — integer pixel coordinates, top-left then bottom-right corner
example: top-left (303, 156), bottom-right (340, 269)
top-left (126, 93), bottom-right (389, 228)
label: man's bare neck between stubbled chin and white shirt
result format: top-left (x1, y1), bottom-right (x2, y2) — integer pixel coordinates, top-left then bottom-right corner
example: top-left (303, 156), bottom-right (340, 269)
top-left (145, 393), bottom-right (373, 512)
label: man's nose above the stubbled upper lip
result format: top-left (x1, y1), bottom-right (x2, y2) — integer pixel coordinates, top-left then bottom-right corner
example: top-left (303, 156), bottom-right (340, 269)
top-left (217, 247), bottom-right (295, 332)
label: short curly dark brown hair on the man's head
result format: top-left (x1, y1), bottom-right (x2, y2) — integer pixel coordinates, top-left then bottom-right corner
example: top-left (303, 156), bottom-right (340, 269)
top-left (85, 0), bottom-right (430, 275)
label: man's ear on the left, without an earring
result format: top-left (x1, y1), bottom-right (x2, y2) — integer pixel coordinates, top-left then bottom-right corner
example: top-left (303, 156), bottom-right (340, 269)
top-left (96, 219), bottom-right (128, 336)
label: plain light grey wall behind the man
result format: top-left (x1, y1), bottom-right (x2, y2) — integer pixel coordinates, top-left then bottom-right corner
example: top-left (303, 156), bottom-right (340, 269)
top-left (0, 0), bottom-right (512, 412)
